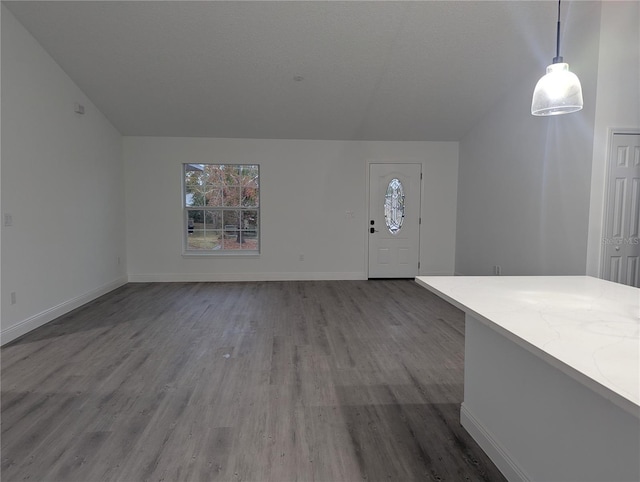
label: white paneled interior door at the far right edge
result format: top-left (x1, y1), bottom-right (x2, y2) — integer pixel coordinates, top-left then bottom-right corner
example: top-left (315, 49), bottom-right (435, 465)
top-left (603, 134), bottom-right (640, 287)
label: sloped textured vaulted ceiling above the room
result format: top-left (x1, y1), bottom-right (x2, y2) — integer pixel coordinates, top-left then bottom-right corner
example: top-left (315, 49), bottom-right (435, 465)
top-left (3, 0), bottom-right (593, 141)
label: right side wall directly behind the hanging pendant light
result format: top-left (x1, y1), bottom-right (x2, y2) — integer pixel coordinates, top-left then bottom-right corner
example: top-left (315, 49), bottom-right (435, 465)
top-left (456, 2), bottom-right (600, 275)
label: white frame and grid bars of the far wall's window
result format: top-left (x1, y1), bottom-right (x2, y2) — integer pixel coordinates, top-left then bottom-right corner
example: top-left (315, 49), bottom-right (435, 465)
top-left (181, 162), bottom-right (261, 257)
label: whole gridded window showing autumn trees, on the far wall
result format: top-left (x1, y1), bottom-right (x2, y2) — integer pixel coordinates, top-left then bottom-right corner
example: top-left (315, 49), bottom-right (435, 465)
top-left (183, 164), bottom-right (260, 254)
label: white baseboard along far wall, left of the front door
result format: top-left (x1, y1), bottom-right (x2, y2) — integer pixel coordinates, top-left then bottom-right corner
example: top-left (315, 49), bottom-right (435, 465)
top-left (129, 272), bottom-right (367, 283)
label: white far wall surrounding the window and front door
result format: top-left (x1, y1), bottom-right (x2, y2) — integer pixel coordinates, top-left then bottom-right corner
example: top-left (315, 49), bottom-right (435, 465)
top-left (124, 137), bottom-right (458, 281)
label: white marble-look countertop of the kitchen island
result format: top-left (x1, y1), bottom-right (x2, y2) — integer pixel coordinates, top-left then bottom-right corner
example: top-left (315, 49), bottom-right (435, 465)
top-left (416, 276), bottom-right (640, 416)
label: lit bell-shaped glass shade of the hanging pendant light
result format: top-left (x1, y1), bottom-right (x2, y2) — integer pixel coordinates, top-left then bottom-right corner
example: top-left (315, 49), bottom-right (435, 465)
top-left (531, 63), bottom-right (582, 116)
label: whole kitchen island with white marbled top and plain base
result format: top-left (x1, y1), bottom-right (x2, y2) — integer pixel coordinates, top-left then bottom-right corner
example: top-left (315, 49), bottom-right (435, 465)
top-left (416, 276), bottom-right (640, 481)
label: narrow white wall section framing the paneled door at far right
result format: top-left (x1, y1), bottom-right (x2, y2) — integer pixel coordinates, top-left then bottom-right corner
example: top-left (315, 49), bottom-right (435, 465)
top-left (587, 1), bottom-right (640, 276)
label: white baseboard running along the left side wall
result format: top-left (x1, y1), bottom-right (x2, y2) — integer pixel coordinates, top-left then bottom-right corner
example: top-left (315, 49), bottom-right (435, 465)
top-left (0, 276), bottom-right (127, 345)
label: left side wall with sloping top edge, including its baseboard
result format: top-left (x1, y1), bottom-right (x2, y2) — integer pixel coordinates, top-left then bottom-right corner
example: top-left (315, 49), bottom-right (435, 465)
top-left (1, 6), bottom-right (126, 343)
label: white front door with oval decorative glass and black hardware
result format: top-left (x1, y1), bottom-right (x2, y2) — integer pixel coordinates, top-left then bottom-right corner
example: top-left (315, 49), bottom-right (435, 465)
top-left (368, 164), bottom-right (422, 278)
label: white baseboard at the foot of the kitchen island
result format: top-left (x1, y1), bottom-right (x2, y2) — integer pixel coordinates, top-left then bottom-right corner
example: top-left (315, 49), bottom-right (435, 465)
top-left (460, 402), bottom-right (531, 482)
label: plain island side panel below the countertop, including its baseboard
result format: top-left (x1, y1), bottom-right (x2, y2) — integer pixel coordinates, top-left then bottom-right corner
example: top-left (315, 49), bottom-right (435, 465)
top-left (461, 314), bottom-right (640, 482)
